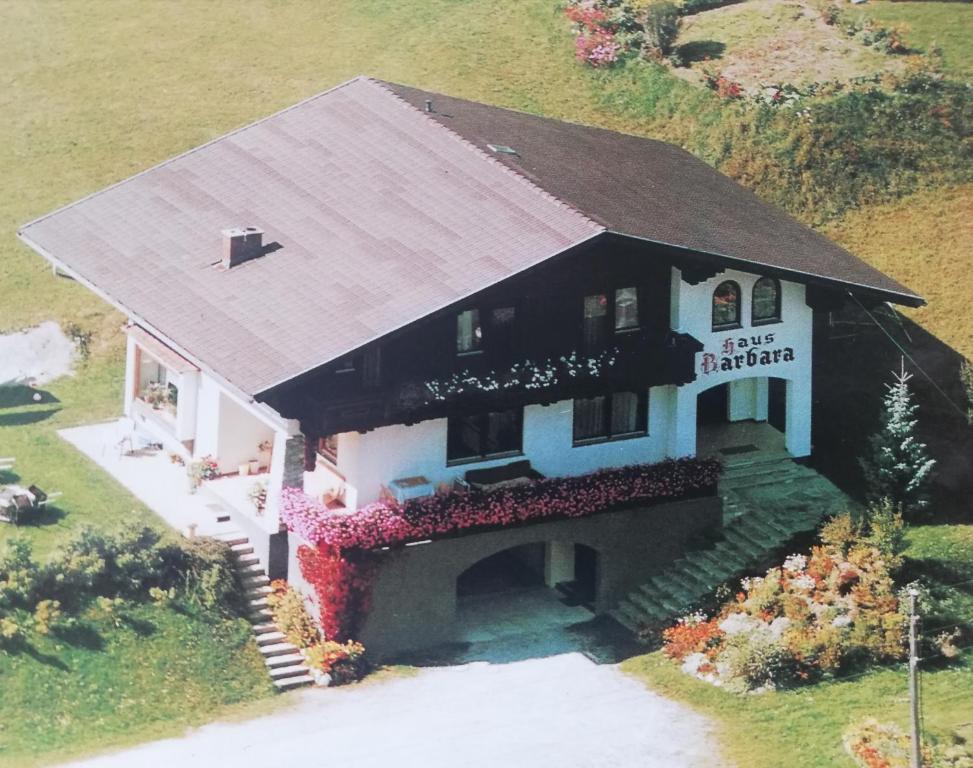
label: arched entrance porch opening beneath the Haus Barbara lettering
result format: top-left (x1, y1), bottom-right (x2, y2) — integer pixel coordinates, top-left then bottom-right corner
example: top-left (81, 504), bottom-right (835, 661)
top-left (696, 376), bottom-right (788, 456)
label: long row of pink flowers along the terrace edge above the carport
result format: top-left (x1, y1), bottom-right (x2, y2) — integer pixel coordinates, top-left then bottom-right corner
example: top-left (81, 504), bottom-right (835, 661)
top-left (281, 459), bottom-right (721, 551)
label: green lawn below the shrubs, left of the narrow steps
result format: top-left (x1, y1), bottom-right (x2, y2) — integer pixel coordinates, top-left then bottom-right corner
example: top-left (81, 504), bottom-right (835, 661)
top-left (0, 605), bottom-right (273, 768)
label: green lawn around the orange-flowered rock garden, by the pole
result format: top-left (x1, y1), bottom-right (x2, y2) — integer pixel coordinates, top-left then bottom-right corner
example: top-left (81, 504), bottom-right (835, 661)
top-left (623, 525), bottom-right (973, 768)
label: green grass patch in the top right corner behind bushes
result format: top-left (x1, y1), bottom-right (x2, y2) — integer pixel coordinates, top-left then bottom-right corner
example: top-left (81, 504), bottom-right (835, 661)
top-left (863, 0), bottom-right (973, 82)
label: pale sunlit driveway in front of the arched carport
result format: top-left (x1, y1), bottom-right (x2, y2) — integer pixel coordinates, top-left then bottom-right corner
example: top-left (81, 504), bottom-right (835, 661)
top-left (60, 616), bottom-right (721, 768)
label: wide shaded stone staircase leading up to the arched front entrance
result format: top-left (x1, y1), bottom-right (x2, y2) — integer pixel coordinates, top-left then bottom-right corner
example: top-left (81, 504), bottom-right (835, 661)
top-left (610, 452), bottom-right (851, 632)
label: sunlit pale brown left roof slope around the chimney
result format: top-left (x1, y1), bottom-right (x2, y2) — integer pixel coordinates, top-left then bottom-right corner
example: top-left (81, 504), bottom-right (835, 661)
top-left (21, 79), bottom-right (603, 394)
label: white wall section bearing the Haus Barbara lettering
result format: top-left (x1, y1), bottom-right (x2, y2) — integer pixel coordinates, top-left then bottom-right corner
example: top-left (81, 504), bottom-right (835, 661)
top-left (670, 269), bottom-right (812, 456)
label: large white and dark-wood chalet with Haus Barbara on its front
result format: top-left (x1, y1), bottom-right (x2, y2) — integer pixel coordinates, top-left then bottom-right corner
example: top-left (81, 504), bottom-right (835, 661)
top-left (19, 78), bottom-right (922, 648)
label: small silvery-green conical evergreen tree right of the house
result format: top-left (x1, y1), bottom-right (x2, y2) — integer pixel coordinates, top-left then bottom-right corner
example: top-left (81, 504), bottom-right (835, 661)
top-left (860, 362), bottom-right (936, 517)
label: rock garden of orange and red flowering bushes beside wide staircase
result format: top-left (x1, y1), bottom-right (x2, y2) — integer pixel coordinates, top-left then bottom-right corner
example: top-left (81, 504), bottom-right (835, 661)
top-left (663, 506), bottom-right (906, 691)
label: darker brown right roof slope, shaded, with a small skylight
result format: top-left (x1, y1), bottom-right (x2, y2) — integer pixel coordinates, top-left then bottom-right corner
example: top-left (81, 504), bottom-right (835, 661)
top-left (386, 83), bottom-right (923, 304)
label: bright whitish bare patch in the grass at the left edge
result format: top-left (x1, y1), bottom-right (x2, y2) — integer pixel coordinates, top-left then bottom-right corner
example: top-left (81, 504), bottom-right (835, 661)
top-left (0, 321), bottom-right (75, 387)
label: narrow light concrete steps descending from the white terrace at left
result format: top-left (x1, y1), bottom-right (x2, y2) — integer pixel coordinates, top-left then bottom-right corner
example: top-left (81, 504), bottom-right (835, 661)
top-left (216, 531), bottom-right (314, 691)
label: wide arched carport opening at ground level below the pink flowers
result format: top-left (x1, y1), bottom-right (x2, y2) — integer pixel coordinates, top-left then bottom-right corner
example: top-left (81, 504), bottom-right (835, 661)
top-left (456, 542), bottom-right (599, 642)
